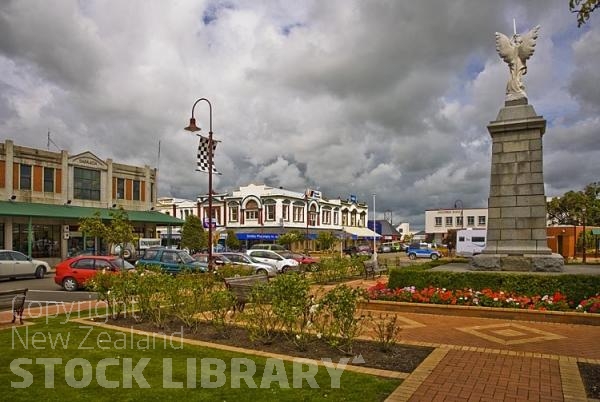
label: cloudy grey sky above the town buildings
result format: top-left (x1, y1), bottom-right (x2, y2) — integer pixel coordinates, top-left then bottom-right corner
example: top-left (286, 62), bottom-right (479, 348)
top-left (0, 0), bottom-right (600, 228)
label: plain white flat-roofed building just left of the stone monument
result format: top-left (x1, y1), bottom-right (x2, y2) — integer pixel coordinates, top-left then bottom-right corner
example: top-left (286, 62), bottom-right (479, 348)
top-left (425, 208), bottom-right (488, 243)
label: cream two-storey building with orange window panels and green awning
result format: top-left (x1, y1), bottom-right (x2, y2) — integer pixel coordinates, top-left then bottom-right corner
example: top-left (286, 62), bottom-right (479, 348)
top-left (0, 140), bottom-right (181, 264)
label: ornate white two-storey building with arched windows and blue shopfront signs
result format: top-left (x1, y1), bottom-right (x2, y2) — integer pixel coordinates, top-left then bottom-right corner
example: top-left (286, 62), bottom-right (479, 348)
top-left (157, 184), bottom-right (378, 249)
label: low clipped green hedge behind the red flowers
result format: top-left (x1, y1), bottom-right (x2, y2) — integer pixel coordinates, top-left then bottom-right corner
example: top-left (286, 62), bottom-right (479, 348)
top-left (388, 268), bottom-right (600, 302)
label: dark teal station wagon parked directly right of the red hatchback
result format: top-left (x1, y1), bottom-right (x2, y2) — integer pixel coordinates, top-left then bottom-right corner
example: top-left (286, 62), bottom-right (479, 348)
top-left (135, 247), bottom-right (208, 274)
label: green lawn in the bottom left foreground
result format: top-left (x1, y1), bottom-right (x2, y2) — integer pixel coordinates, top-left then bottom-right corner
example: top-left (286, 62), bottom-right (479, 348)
top-left (0, 316), bottom-right (401, 401)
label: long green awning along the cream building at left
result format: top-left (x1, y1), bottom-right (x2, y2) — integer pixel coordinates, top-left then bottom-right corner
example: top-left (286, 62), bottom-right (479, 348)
top-left (0, 201), bottom-right (184, 226)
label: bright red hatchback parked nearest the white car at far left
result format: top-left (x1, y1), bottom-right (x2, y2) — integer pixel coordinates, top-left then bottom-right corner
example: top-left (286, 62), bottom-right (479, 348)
top-left (54, 255), bottom-right (134, 292)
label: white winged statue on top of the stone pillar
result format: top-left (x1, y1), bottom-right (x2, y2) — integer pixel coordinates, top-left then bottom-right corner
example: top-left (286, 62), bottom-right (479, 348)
top-left (496, 25), bottom-right (540, 101)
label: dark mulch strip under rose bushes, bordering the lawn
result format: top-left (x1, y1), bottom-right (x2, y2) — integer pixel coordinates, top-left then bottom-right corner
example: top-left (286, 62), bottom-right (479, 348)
top-left (102, 317), bottom-right (433, 373)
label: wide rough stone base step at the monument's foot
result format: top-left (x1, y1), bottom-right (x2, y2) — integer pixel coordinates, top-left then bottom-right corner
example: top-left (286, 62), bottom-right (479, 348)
top-left (469, 254), bottom-right (565, 272)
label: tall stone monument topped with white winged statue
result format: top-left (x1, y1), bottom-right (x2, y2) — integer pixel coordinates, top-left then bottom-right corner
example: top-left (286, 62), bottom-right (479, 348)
top-left (471, 26), bottom-right (564, 272)
